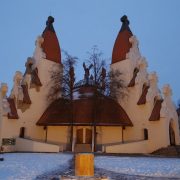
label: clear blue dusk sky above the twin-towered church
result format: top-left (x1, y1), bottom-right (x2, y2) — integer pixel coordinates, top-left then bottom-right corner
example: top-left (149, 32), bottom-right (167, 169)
top-left (0, 0), bottom-right (180, 103)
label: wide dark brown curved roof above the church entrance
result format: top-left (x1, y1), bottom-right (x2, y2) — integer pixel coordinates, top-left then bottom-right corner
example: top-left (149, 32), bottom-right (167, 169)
top-left (37, 97), bottom-right (133, 126)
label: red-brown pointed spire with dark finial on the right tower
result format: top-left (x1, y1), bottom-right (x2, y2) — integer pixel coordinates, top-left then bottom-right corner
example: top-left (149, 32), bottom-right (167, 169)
top-left (112, 15), bottom-right (133, 64)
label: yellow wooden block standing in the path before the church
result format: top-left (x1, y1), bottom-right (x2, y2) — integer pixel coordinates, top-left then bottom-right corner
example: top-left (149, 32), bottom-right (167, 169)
top-left (75, 153), bottom-right (94, 176)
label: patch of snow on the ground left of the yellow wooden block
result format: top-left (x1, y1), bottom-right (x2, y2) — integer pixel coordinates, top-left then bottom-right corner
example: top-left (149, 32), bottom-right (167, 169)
top-left (0, 153), bottom-right (73, 180)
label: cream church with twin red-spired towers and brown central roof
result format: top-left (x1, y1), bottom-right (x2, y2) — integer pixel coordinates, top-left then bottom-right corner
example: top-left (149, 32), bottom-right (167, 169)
top-left (0, 16), bottom-right (180, 153)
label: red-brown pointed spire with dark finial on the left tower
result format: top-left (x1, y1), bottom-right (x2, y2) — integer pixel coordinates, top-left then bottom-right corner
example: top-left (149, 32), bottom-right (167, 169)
top-left (42, 16), bottom-right (61, 63)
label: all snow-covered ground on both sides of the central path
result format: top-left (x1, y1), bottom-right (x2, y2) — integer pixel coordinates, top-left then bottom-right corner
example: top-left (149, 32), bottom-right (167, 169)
top-left (0, 153), bottom-right (180, 180)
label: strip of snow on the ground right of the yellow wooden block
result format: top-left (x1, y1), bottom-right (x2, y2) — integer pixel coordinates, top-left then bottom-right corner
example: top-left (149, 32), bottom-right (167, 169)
top-left (95, 156), bottom-right (180, 179)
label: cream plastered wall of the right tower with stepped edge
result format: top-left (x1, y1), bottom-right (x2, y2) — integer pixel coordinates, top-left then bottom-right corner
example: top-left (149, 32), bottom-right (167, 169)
top-left (109, 35), bottom-right (179, 153)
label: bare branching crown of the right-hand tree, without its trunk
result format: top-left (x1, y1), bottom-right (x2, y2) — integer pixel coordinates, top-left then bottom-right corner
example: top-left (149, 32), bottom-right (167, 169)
top-left (87, 46), bottom-right (127, 100)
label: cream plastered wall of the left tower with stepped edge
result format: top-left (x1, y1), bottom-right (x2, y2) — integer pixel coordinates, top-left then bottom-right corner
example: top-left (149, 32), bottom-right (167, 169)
top-left (0, 36), bottom-right (62, 148)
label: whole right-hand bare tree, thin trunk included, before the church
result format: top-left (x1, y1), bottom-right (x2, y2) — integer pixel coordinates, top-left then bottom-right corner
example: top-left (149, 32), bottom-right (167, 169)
top-left (83, 46), bottom-right (126, 151)
